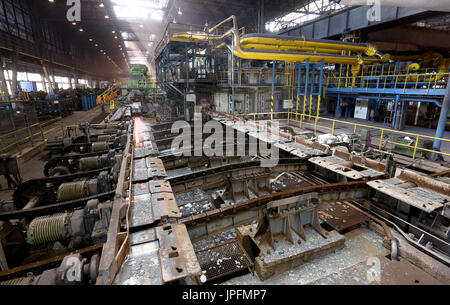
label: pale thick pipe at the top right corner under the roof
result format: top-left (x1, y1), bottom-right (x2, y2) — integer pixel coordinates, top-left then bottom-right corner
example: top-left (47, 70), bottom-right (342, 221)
top-left (334, 0), bottom-right (450, 12)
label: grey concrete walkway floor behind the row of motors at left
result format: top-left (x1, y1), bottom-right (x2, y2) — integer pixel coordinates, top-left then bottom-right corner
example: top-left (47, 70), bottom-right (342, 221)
top-left (0, 107), bottom-right (108, 201)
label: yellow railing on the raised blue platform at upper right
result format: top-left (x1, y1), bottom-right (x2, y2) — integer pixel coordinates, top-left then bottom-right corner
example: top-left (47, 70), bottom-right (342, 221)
top-left (325, 72), bottom-right (450, 95)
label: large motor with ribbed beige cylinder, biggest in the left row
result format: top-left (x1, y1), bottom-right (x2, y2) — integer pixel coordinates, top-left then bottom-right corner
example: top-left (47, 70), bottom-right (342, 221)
top-left (0, 200), bottom-right (112, 268)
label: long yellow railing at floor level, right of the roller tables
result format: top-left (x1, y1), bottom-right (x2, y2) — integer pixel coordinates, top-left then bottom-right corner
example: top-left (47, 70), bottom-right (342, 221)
top-left (236, 112), bottom-right (450, 160)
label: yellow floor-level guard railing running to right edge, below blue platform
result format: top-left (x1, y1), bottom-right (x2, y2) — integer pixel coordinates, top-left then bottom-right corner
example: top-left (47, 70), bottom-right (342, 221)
top-left (236, 111), bottom-right (450, 160)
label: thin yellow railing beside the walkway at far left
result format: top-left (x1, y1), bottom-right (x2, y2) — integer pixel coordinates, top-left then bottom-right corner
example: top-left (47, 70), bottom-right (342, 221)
top-left (0, 117), bottom-right (64, 155)
